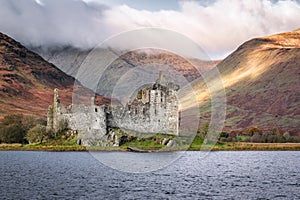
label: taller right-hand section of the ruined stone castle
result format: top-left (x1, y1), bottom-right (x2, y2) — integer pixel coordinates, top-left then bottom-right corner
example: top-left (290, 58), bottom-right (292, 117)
top-left (110, 75), bottom-right (179, 135)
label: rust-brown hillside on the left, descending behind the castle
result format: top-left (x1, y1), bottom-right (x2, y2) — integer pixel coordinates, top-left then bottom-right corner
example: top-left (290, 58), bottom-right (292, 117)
top-left (0, 33), bottom-right (109, 120)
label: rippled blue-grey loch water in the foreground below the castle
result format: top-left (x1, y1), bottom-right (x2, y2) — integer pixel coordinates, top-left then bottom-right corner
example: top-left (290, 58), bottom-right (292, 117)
top-left (0, 151), bottom-right (300, 199)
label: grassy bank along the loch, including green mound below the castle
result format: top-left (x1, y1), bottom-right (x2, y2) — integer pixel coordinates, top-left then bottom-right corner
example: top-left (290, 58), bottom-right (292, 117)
top-left (0, 134), bottom-right (300, 151)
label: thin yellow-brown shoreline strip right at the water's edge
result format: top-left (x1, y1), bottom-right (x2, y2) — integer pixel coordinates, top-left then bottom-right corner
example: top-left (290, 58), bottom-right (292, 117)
top-left (0, 142), bottom-right (300, 153)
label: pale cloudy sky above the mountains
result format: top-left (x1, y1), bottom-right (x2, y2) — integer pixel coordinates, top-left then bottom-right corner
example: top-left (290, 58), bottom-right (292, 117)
top-left (0, 0), bottom-right (300, 59)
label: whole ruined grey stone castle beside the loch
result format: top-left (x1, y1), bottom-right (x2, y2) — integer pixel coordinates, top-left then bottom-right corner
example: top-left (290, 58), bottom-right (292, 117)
top-left (47, 72), bottom-right (179, 145)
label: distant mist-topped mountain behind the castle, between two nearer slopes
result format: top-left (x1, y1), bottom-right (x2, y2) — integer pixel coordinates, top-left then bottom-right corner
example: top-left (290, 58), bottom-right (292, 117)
top-left (31, 46), bottom-right (220, 97)
